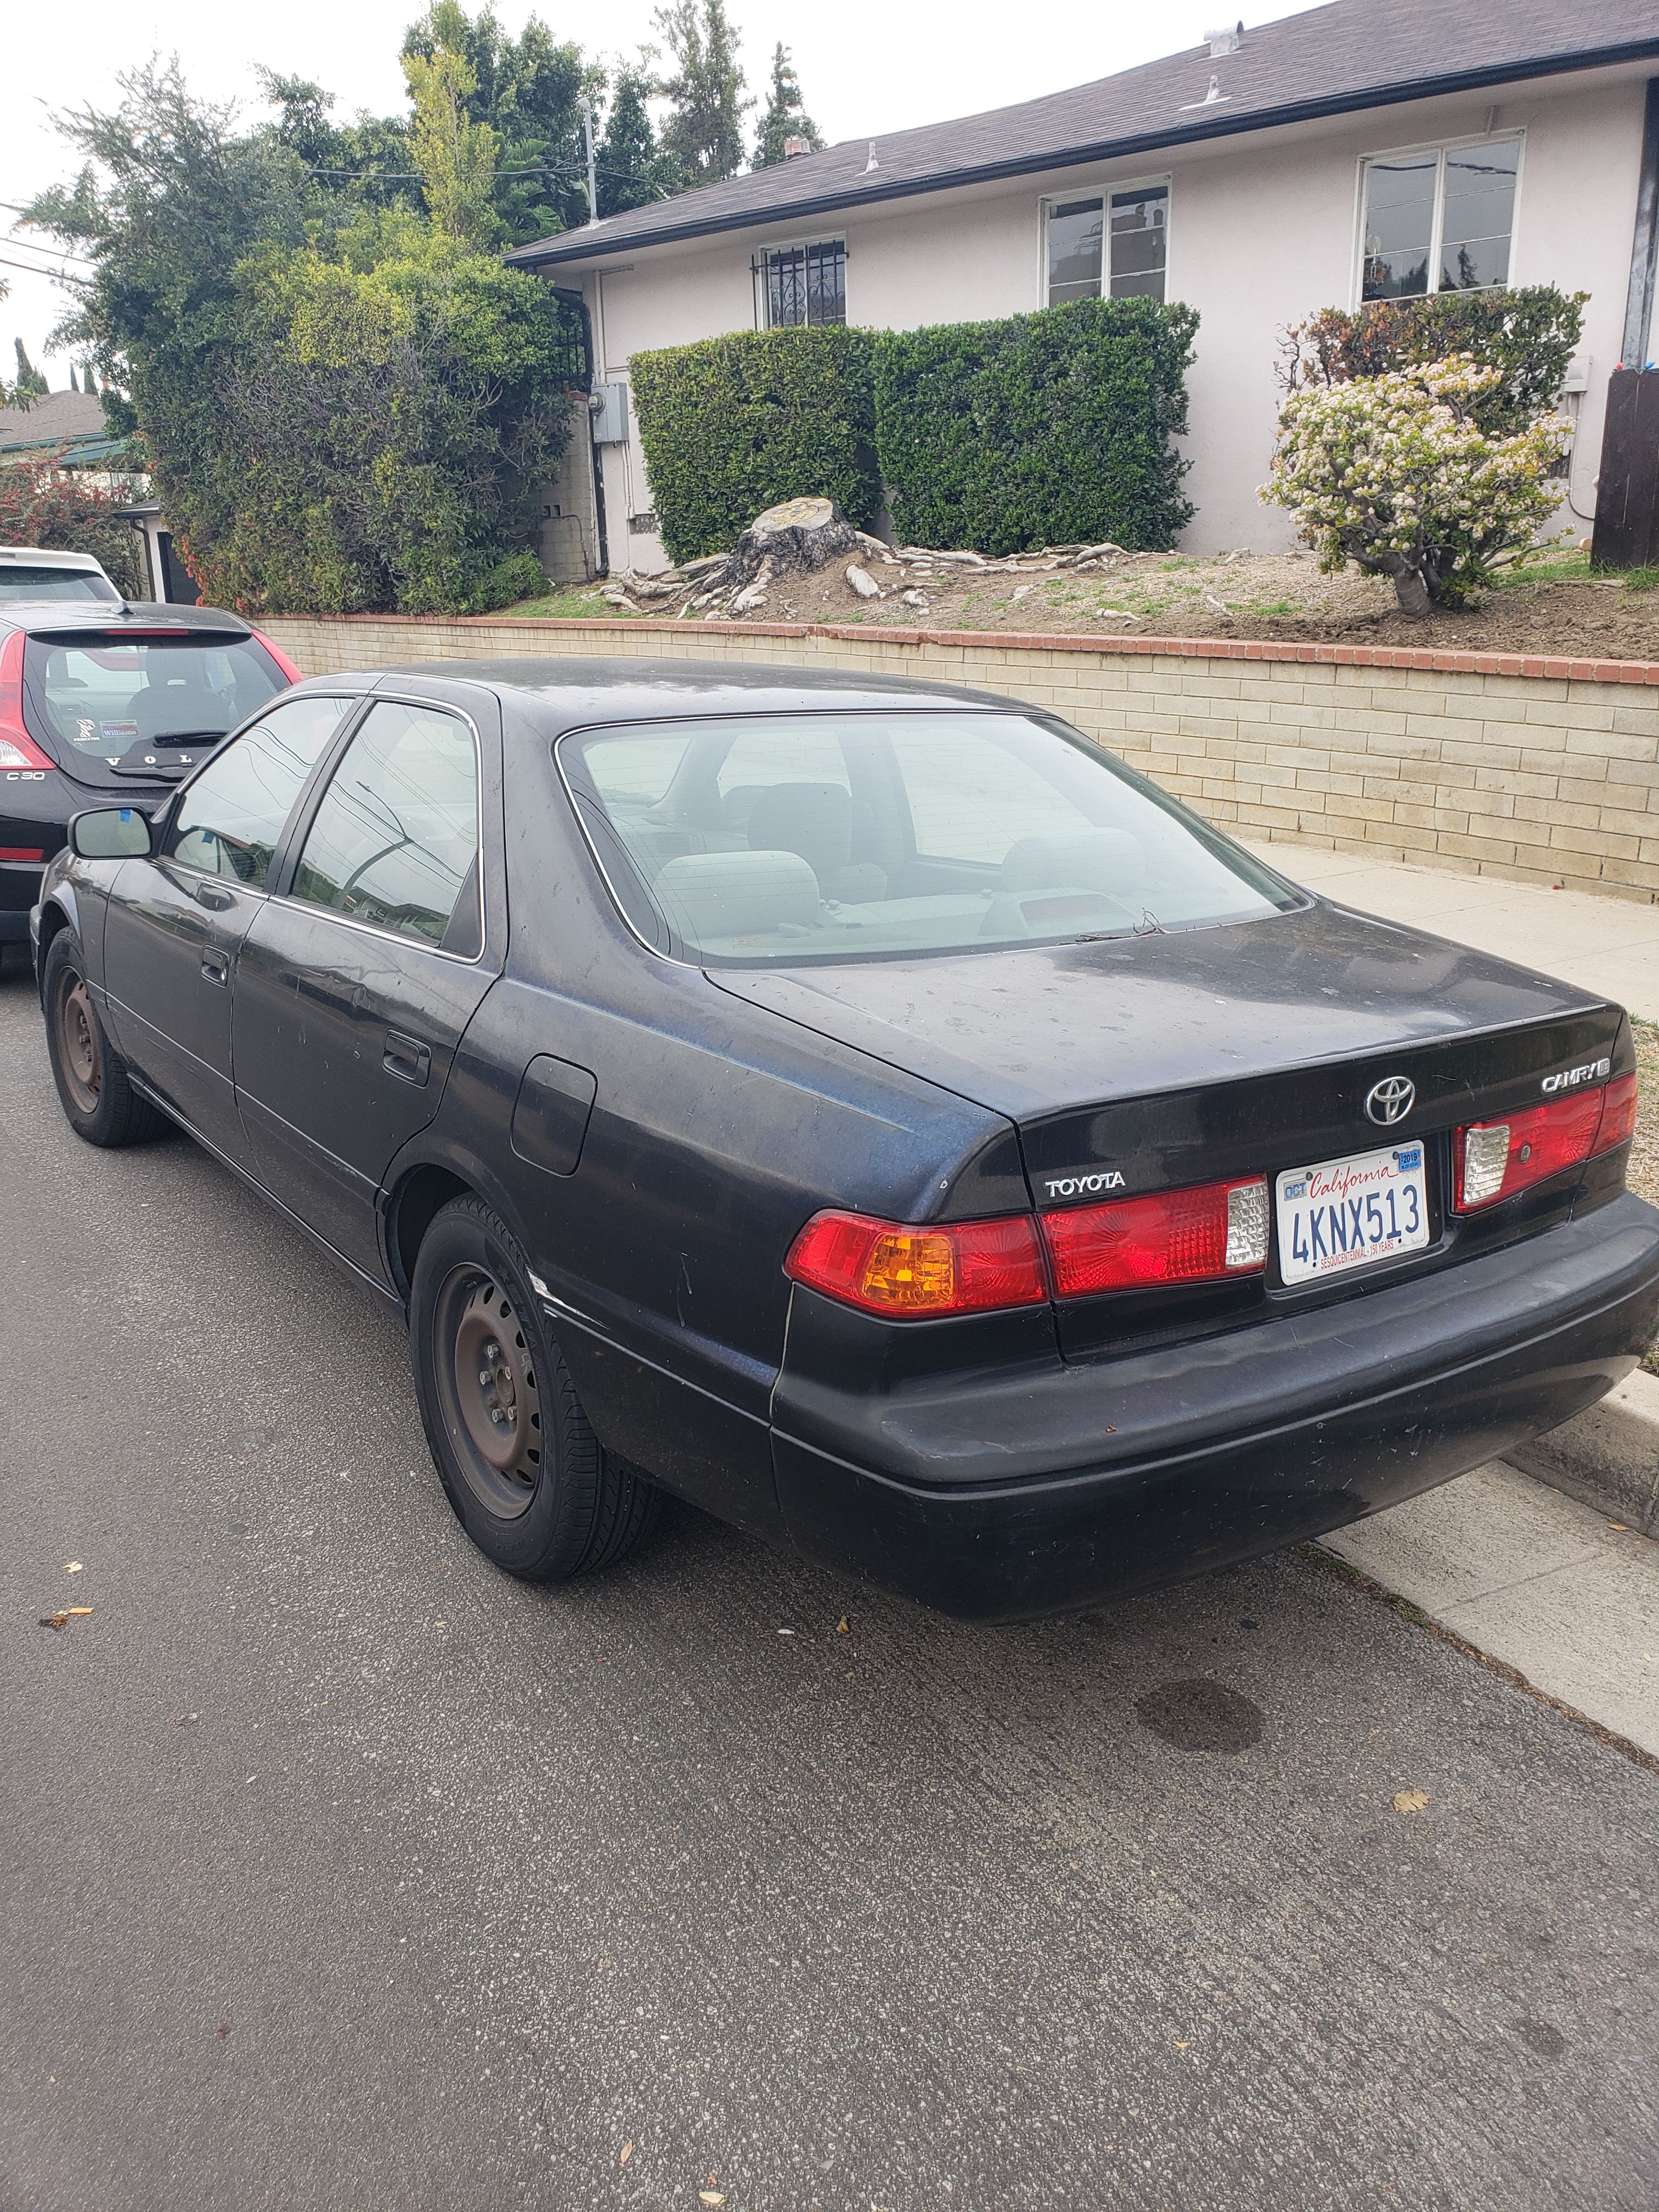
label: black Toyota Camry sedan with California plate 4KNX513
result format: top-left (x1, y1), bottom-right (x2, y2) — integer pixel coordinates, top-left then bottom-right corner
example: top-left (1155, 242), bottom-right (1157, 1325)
top-left (36, 662), bottom-right (1659, 1619)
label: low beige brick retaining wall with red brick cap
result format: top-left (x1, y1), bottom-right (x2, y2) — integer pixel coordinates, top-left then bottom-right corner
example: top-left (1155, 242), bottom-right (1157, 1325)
top-left (263, 615), bottom-right (1659, 905)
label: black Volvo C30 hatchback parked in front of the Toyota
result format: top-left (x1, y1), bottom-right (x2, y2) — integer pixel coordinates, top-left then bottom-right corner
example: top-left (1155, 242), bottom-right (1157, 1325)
top-left (0, 597), bottom-right (298, 947)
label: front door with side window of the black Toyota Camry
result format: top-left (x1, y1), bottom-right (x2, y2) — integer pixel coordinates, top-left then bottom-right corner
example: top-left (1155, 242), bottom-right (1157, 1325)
top-left (104, 692), bottom-right (358, 1166)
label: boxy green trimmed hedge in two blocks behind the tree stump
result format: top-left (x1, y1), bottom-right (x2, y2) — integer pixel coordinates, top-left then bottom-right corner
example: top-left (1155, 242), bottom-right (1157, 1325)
top-left (630, 298), bottom-right (1199, 562)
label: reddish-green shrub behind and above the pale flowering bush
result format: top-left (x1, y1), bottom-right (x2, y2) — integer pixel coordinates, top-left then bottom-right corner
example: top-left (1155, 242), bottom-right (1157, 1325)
top-left (1283, 283), bottom-right (1590, 438)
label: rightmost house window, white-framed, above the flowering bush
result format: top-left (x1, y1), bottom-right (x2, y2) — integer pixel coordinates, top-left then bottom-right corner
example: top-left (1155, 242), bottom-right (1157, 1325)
top-left (1361, 137), bottom-right (1520, 301)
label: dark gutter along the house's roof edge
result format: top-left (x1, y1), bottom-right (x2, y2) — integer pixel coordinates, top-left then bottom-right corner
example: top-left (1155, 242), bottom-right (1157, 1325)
top-left (504, 36), bottom-right (1659, 270)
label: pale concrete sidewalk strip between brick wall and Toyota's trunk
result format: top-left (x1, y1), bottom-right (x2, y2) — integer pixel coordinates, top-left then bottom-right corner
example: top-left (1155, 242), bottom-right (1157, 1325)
top-left (1241, 838), bottom-right (1659, 1022)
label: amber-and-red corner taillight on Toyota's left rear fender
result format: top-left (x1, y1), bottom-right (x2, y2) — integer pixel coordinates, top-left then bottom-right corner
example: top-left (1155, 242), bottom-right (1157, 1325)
top-left (783, 1212), bottom-right (1048, 1318)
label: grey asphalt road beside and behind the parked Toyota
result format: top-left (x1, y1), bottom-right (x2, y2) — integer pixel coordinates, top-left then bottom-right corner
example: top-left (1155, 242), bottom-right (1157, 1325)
top-left (0, 978), bottom-right (1659, 2212)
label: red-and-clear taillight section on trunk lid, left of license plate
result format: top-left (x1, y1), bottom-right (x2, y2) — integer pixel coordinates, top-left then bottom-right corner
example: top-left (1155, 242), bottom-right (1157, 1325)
top-left (1042, 1177), bottom-right (1267, 1299)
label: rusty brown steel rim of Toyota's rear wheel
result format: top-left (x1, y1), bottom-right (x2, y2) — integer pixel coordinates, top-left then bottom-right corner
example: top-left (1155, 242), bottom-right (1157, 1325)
top-left (433, 1267), bottom-right (542, 1520)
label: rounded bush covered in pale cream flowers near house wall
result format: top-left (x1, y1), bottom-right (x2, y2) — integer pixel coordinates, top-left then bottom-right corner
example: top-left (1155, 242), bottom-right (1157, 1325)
top-left (1261, 354), bottom-right (1573, 615)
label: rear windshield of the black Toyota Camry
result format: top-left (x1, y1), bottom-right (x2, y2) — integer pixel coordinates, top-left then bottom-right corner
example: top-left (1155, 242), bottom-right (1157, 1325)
top-left (557, 710), bottom-right (1301, 967)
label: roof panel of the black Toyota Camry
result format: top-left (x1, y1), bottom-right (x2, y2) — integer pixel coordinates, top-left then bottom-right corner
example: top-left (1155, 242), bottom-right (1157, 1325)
top-left (327, 654), bottom-right (1015, 732)
